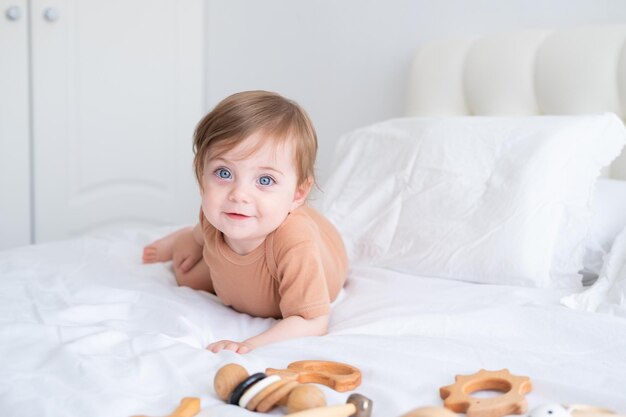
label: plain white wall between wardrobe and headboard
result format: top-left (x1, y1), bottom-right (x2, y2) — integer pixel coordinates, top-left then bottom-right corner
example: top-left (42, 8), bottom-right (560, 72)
top-left (206, 0), bottom-right (626, 183)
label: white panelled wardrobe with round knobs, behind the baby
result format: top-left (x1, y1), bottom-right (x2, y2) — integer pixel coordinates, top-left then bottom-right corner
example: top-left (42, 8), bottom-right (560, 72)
top-left (0, 0), bottom-right (205, 250)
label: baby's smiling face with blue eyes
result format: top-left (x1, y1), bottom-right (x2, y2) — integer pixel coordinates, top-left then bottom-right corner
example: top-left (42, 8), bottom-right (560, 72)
top-left (202, 134), bottom-right (306, 255)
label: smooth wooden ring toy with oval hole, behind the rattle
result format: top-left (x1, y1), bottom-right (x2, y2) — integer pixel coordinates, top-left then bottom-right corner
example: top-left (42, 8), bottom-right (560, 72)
top-left (265, 360), bottom-right (361, 392)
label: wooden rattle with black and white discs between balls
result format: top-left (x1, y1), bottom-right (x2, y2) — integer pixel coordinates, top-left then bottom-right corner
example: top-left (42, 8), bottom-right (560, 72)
top-left (213, 363), bottom-right (326, 413)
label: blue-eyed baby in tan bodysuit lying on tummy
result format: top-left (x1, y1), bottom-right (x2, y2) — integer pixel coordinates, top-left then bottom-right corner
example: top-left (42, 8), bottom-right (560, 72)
top-left (143, 91), bottom-right (348, 353)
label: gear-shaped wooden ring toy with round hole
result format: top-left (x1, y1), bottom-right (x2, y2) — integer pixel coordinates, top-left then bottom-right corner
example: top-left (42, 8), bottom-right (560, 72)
top-left (439, 369), bottom-right (532, 417)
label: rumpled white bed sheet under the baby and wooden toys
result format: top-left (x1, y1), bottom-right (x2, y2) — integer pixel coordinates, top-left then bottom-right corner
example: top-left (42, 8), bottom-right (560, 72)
top-left (0, 230), bottom-right (626, 417)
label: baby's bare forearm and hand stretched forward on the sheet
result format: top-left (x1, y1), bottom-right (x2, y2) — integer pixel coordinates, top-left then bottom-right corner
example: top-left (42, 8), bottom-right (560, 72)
top-left (207, 315), bottom-right (328, 353)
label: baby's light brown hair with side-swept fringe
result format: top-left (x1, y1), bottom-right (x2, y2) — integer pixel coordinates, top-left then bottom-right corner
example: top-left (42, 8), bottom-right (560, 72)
top-left (193, 91), bottom-right (317, 187)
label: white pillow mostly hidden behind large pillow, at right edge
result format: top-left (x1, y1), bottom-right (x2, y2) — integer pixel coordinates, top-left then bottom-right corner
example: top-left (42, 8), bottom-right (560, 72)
top-left (582, 178), bottom-right (626, 283)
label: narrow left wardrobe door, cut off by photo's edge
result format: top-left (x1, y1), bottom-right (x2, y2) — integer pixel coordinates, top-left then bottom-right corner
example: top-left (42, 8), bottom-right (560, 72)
top-left (0, 0), bottom-right (31, 250)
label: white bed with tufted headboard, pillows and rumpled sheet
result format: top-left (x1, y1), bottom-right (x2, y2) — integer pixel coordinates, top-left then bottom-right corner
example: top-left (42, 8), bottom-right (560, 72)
top-left (0, 26), bottom-right (626, 417)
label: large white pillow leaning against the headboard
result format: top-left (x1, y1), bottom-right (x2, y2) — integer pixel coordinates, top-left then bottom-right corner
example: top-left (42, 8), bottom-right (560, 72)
top-left (321, 114), bottom-right (626, 288)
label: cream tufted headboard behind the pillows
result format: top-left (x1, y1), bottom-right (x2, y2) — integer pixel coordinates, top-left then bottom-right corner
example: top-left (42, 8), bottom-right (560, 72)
top-left (406, 25), bottom-right (626, 180)
